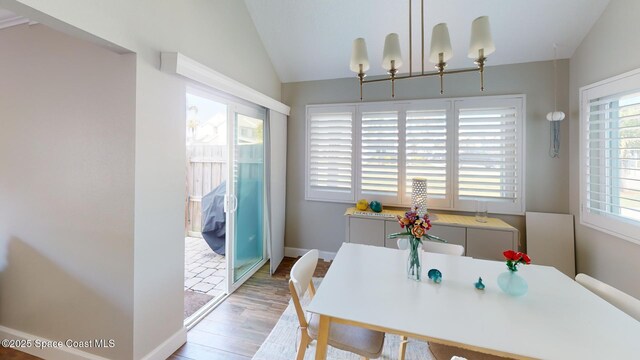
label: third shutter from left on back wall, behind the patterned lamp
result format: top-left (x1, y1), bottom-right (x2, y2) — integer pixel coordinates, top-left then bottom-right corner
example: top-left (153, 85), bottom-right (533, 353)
top-left (405, 109), bottom-right (448, 199)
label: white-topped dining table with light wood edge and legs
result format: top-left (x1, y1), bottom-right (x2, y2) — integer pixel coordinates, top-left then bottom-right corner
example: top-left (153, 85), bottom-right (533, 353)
top-left (307, 243), bottom-right (640, 360)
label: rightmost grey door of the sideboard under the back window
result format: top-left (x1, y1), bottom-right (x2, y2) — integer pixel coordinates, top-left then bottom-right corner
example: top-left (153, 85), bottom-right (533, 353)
top-left (467, 229), bottom-right (517, 260)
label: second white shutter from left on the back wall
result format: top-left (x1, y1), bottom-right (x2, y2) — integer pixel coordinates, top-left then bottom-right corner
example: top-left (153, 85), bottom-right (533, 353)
top-left (360, 111), bottom-right (399, 203)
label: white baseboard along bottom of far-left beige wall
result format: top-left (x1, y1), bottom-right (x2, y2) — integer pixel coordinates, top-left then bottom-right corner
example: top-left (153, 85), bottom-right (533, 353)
top-left (0, 325), bottom-right (109, 360)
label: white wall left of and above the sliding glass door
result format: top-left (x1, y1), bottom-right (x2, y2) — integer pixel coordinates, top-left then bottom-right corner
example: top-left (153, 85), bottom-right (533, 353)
top-left (0, 0), bottom-right (281, 359)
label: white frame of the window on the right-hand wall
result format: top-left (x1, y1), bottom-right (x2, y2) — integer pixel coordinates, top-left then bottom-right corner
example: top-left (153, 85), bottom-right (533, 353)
top-left (578, 69), bottom-right (640, 244)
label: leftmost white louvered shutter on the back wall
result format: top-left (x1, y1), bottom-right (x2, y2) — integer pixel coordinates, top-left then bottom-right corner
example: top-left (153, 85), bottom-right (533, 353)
top-left (307, 106), bottom-right (355, 201)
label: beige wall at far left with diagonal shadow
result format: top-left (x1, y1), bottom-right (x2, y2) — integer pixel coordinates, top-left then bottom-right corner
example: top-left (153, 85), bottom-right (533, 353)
top-left (0, 25), bottom-right (135, 359)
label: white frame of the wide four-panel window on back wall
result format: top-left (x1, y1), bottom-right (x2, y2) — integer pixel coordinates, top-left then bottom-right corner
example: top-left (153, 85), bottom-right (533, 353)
top-left (304, 94), bottom-right (526, 215)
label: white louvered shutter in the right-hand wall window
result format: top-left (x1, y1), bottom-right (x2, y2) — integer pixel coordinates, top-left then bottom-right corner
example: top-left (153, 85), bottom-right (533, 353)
top-left (584, 91), bottom-right (640, 225)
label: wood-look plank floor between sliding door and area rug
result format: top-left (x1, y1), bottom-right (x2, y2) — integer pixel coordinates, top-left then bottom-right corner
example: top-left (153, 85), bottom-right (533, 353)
top-left (0, 258), bottom-right (331, 360)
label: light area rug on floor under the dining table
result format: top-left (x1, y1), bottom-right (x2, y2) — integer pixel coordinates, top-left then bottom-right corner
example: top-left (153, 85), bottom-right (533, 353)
top-left (253, 279), bottom-right (432, 360)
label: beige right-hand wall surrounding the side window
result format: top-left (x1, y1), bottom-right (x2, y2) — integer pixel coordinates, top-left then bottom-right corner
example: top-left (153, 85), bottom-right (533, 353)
top-left (570, 0), bottom-right (640, 298)
